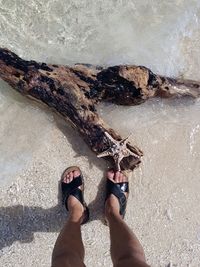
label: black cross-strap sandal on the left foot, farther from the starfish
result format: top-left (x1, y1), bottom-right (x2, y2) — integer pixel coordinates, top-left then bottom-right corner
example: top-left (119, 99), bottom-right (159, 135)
top-left (61, 166), bottom-right (90, 224)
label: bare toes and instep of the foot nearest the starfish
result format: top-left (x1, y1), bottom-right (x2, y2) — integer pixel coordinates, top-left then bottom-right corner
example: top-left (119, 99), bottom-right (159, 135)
top-left (105, 170), bottom-right (128, 217)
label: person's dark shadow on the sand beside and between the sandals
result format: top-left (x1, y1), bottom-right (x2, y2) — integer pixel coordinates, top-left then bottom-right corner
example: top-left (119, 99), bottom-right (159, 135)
top-left (0, 174), bottom-right (108, 250)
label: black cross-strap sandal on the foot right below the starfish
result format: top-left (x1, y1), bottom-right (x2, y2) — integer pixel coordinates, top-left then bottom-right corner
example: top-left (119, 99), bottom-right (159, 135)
top-left (105, 178), bottom-right (129, 219)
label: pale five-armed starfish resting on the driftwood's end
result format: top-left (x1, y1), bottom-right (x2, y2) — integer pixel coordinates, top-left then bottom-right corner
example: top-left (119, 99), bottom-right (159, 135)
top-left (97, 132), bottom-right (140, 171)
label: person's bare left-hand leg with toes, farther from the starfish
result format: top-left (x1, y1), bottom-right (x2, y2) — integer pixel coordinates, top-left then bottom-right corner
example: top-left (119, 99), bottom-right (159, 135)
top-left (52, 171), bottom-right (85, 267)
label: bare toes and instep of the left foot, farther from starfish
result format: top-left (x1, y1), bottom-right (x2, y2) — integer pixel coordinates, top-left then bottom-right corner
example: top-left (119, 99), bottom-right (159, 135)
top-left (62, 170), bottom-right (84, 224)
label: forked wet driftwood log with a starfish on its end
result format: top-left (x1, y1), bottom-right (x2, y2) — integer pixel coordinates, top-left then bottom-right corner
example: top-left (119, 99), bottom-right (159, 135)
top-left (0, 48), bottom-right (200, 170)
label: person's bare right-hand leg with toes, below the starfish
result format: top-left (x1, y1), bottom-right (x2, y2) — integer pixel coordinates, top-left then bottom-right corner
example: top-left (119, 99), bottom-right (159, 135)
top-left (105, 171), bottom-right (149, 267)
